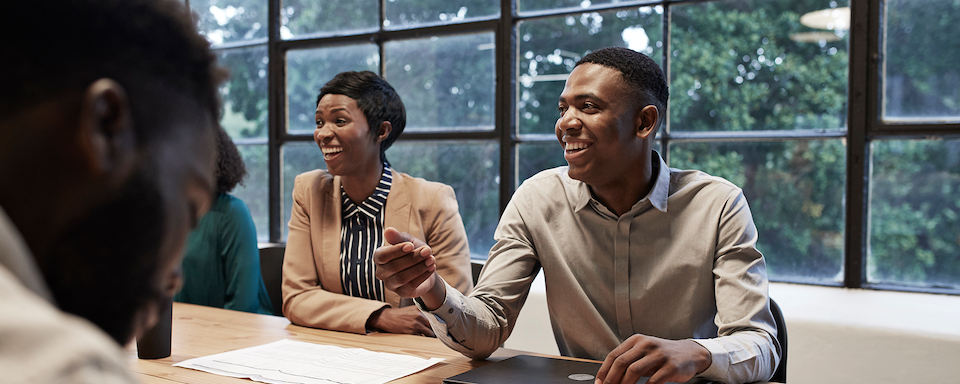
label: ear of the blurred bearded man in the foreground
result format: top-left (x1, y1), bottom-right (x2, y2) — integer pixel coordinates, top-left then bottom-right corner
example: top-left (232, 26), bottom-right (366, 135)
top-left (77, 79), bottom-right (136, 177)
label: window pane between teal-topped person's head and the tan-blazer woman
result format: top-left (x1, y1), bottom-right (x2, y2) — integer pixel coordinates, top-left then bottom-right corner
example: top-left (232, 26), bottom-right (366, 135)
top-left (230, 144), bottom-right (270, 242)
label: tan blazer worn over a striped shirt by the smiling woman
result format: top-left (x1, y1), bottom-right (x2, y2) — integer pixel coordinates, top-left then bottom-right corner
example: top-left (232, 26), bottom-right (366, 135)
top-left (282, 170), bottom-right (473, 333)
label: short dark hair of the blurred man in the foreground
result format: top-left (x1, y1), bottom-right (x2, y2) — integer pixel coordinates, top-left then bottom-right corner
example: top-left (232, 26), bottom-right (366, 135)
top-left (0, 0), bottom-right (225, 144)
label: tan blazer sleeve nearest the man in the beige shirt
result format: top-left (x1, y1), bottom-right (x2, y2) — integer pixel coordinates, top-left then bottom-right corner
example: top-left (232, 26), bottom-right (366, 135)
top-left (424, 185), bottom-right (473, 294)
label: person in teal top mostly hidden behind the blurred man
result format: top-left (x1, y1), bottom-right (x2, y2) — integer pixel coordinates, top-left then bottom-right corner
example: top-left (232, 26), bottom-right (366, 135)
top-left (173, 129), bottom-right (273, 314)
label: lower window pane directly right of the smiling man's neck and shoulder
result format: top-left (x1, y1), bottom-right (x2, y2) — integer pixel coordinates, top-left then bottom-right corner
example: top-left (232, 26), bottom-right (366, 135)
top-left (670, 140), bottom-right (846, 283)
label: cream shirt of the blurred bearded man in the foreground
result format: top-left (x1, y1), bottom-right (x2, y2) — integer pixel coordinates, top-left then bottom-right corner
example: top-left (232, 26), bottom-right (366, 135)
top-left (0, 207), bottom-right (137, 384)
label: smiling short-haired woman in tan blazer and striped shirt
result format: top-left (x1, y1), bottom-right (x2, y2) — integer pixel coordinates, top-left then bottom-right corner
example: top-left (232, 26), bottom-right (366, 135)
top-left (283, 71), bottom-right (473, 335)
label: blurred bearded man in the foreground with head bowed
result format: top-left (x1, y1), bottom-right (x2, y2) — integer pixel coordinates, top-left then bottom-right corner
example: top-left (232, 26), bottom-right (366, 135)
top-left (0, 0), bottom-right (222, 383)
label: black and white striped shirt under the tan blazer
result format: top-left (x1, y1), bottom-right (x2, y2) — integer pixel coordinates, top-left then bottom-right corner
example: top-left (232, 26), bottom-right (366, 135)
top-left (340, 163), bottom-right (393, 301)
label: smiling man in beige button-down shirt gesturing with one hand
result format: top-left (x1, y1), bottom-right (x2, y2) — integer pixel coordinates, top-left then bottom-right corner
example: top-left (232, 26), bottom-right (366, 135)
top-left (375, 48), bottom-right (780, 384)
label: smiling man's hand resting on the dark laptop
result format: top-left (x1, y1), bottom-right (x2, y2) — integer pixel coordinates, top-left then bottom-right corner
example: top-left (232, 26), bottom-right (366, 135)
top-left (596, 335), bottom-right (712, 384)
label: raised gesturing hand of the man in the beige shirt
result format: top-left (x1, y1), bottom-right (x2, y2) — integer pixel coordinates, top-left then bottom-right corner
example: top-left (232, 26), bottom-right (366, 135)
top-left (373, 227), bottom-right (446, 309)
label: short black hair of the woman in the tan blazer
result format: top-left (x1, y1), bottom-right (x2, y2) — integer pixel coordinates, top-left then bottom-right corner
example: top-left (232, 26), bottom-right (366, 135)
top-left (317, 71), bottom-right (407, 161)
